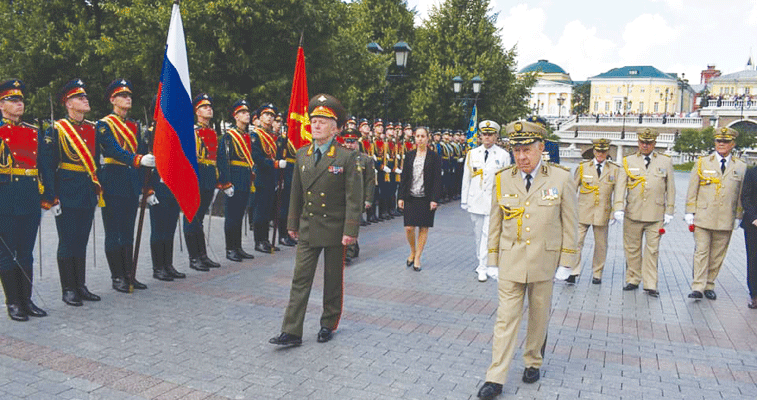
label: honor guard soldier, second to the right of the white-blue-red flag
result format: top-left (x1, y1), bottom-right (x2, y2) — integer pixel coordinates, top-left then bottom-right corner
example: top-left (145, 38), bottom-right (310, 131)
top-left (218, 100), bottom-right (255, 262)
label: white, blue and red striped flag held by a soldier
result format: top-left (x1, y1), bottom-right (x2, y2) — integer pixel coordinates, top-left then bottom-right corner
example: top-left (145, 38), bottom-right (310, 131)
top-left (153, 2), bottom-right (200, 222)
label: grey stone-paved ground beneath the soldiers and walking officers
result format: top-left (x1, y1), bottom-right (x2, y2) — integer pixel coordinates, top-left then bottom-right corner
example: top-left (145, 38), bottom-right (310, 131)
top-left (0, 173), bottom-right (757, 400)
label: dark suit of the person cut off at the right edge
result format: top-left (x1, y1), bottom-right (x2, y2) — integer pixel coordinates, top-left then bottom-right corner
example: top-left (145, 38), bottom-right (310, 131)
top-left (741, 167), bottom-right (757, 298)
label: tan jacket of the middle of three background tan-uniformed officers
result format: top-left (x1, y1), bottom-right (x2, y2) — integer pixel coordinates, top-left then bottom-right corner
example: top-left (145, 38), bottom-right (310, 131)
top-left (615, 151), bottom-right (676, 222)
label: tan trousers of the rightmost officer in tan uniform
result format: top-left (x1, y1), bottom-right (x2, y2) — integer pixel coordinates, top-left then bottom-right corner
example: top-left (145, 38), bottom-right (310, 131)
top-left (691, 226), bottom-right (733, 292)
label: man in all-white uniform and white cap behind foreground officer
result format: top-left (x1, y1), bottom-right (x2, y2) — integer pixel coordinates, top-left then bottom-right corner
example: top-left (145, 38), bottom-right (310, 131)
top-left (460, 120), bottom-right (511, 282)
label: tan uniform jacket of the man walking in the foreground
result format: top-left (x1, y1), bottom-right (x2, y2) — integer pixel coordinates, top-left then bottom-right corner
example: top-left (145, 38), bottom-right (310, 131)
top-left (488, 161), bottom-right (578, 283)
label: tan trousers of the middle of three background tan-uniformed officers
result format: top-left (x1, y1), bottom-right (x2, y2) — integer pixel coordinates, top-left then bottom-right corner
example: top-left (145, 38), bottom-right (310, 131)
top-left (623, 218), bottom-right (662, 290)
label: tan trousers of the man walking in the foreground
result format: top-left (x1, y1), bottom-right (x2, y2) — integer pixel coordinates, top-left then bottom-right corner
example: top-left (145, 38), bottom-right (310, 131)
top-left (486, 278), bottom-right (552, 384)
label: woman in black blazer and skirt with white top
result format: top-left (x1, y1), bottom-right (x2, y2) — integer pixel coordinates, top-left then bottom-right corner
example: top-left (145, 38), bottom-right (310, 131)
top-left (397, 127), bottom-right (442, 271)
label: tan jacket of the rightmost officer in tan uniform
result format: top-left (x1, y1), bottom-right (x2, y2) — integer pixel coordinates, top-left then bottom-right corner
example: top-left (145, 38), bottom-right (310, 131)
top-left (686, 154), bottom-right (746, 231)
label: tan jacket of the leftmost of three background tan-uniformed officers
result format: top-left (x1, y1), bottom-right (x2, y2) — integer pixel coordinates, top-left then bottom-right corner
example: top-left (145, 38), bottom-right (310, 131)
top-left (573, 159), bottom-right (626, 226)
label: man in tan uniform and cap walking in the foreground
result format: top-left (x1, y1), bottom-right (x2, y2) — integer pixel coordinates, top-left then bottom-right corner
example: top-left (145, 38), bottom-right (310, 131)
top-left (478, 121), bottom-right (578, 399)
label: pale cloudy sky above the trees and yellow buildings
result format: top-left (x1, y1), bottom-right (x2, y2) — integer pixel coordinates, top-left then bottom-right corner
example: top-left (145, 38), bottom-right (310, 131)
top-left (407, 0), bottom-right (757, 84)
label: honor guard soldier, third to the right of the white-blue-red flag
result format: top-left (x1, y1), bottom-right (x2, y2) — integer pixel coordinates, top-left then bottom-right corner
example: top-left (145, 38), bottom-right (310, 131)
top-left (250, 103), bottom-right (287, 253)
